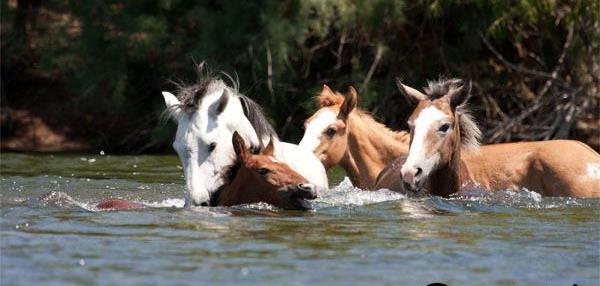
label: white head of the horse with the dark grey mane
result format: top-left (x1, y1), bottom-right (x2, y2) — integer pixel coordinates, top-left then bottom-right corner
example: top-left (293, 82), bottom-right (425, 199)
top-left (163, 65), bottom-right (274, 206)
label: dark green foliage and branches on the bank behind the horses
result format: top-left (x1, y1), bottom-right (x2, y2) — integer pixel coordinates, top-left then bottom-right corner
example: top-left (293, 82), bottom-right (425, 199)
top-left (2, 0), bottom-right (600, 151)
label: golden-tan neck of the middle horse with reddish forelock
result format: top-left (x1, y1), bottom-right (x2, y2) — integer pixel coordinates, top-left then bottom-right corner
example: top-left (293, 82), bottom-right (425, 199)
top-left (340, 111), bottom-right (410, 189)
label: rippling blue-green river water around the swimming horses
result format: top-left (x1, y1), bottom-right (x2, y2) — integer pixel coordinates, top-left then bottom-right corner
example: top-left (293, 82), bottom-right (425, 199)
top-left (0, 153), bottom-right (600, 285)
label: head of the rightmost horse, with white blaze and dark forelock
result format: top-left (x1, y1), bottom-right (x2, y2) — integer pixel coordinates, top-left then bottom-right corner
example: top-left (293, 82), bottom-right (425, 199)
top-left (398, 79), bottom-right (481, 190)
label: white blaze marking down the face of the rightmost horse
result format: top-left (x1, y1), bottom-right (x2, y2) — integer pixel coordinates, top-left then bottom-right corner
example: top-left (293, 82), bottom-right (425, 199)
top-left (402, 106), bottom-right (448, 177)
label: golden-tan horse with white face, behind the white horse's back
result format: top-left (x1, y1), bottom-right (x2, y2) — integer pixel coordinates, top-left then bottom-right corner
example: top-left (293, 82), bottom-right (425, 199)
top-left (299, 85), bottom-right (410, 190)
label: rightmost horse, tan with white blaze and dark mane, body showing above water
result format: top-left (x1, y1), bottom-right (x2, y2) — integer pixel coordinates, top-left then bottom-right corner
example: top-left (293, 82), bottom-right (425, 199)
top-left (400, 80), bottom-right (600, 197)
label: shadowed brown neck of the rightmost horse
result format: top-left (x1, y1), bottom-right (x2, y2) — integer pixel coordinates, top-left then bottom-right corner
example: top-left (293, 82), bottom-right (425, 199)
top-left (427, 114), bottom-right (467, 197)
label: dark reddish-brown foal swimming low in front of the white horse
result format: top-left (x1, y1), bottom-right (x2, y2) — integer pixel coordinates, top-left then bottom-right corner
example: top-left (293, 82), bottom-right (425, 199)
top-left (96, 132), bottom-right (317, 210)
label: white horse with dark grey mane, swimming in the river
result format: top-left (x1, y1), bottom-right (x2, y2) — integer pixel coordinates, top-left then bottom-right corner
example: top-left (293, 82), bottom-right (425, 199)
top-left (162, 65), bottom-right (329, 207)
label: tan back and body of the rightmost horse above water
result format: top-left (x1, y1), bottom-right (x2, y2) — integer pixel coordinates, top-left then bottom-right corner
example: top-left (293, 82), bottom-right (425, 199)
top-left (462, 140), bottom-right (600, 197)
